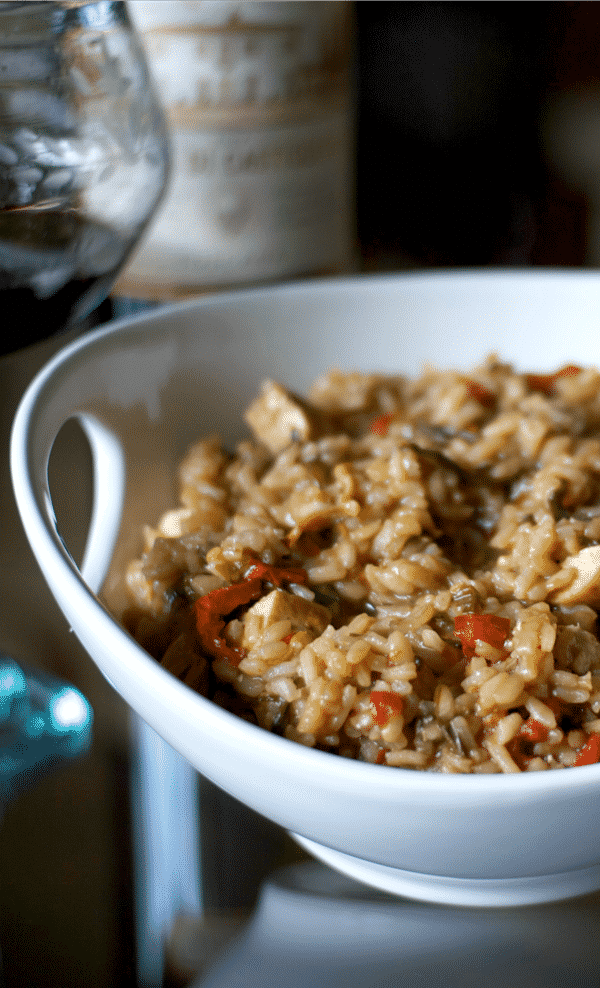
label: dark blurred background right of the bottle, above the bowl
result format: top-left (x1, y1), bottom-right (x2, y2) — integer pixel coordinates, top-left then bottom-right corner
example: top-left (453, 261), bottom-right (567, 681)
top-left (357, 0), bottom-right (600, 269)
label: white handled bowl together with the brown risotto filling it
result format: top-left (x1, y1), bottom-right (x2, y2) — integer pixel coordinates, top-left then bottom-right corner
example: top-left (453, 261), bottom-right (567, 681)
top-left (12, 272), bottom-right (600, 905)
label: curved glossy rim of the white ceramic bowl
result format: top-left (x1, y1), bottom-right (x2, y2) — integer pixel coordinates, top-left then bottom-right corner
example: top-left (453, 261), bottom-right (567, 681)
top-left (10, 269), bottom-right (600, 802)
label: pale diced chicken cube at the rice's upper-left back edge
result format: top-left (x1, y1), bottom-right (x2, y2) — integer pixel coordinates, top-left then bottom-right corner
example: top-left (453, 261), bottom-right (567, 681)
top-left (244, 381), bottom-right (314, 454)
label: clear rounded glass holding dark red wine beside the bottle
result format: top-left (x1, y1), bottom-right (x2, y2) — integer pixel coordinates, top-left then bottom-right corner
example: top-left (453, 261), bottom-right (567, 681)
top-left (0, 0), bottom-right (168, 353)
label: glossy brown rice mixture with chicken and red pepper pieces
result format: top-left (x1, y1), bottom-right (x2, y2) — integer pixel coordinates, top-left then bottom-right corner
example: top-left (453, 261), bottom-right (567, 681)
top-left (123, 357), bottom-right (600, 773)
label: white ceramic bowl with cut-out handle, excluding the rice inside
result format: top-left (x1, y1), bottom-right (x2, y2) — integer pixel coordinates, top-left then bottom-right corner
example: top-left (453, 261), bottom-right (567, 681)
top-left (11, 272), bottom-right (600, 905)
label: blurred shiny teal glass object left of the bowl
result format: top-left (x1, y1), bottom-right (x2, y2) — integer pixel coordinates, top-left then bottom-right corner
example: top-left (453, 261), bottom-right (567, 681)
top-left (0, 655), bottom-right (93, 804)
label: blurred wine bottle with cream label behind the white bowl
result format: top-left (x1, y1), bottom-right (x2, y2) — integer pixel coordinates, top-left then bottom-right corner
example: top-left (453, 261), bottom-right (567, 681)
top-left (117, 0), bottom-right (357, 299)
